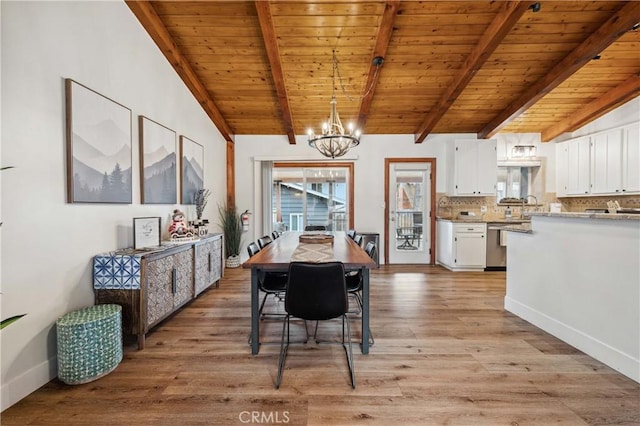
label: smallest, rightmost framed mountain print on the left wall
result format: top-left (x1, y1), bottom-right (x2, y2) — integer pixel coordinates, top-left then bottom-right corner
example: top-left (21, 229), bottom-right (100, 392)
top-left (180, 136), bottom-right (204, 204)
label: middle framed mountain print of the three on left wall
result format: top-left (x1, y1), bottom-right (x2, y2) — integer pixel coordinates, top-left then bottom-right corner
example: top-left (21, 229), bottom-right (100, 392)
top-left (138, 115), bottom-right (178, 204)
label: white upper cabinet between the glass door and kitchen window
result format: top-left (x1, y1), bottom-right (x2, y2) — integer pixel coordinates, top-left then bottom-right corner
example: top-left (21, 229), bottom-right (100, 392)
top-left (447, 139), bottom-right (498, 197)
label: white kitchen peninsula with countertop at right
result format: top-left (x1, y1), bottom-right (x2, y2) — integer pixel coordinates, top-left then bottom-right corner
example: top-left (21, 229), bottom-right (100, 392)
top-left (504, 213), bottom-right (640, 382)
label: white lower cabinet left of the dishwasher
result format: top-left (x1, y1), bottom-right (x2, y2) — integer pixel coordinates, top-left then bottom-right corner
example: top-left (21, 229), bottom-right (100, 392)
top-left (436, 220), bottom-right (487, 271)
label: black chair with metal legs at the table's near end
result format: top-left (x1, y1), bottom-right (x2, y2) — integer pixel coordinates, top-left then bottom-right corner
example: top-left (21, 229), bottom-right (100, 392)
top-left (276, 262), bottom-right (356, 389)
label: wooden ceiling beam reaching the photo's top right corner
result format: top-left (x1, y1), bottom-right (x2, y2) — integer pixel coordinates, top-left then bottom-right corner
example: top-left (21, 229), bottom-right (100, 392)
top-left (478, 1), bottom-right (640, 139)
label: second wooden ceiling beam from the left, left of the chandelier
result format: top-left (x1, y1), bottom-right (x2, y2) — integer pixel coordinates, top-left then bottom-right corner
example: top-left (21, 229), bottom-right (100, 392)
top-left (255, 0), bottom-right (296, 145)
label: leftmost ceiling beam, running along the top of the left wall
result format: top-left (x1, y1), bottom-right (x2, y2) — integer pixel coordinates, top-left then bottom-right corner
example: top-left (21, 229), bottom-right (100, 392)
top-left (126, 0), bottom-right (233, 142)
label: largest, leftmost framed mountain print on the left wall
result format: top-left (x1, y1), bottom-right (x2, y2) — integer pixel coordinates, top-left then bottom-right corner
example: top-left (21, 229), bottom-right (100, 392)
top-left (65, 79), bottom-right (131, 204)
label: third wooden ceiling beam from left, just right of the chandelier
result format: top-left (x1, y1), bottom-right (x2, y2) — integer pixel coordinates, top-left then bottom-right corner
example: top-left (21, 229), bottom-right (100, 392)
top-left (358, 1), bottom-right (400, 129)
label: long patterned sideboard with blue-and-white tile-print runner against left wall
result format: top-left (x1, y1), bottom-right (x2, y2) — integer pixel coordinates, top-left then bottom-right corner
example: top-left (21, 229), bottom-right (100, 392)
top-left (93, 234), bottom-right (223, 349)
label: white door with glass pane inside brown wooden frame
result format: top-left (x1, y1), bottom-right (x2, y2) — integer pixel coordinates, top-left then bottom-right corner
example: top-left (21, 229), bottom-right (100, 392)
top-left (388, 163), bottom-right (431, 264)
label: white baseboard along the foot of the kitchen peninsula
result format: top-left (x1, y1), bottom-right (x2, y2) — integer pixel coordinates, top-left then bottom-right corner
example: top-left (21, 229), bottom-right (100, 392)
top-left (504, 297), bottom-right (640, 383)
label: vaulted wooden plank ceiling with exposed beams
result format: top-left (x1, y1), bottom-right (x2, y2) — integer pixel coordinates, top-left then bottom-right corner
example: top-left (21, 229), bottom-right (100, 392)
top-left (127, 0), bottom-right (640, 143)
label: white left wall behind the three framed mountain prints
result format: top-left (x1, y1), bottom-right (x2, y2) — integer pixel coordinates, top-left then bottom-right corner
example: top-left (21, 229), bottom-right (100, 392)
top-left (0, 1), bottom-right (226, 409)
